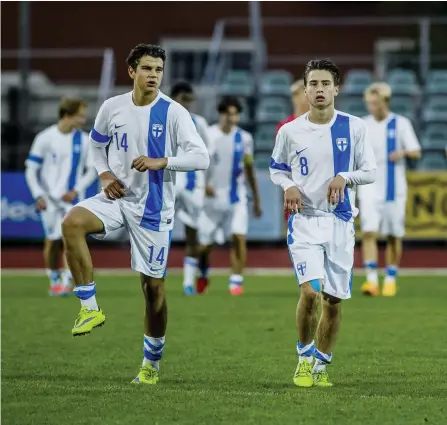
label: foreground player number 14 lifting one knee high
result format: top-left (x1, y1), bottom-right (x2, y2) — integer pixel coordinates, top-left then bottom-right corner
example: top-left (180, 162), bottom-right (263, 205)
top-left (62, 44), bottom-right (209, 384)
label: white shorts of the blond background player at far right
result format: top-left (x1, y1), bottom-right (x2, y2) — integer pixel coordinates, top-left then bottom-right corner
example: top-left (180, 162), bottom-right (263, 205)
top-left (359, 198), bottom-right (406, 238)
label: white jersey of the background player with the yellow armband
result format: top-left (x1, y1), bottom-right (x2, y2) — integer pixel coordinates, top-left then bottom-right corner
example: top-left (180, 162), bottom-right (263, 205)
top-left (208, 124), bottom-right (253, 207)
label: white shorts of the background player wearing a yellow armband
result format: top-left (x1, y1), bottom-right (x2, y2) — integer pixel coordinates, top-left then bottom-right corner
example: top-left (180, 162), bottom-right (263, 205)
top-left (198, 198), bottom-right (248, 245)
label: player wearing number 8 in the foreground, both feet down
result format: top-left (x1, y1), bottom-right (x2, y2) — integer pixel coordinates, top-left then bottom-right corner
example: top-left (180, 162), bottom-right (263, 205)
top-left (270, 60), bottom-right (376, 387)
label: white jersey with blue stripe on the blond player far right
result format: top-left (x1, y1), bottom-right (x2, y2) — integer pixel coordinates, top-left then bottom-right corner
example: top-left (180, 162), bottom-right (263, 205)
top-left (359, 113), bottom-right (421, 202)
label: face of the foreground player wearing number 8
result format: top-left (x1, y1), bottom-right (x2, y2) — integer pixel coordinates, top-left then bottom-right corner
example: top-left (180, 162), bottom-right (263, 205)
top-left (305, 69), bottom-right (338, 109)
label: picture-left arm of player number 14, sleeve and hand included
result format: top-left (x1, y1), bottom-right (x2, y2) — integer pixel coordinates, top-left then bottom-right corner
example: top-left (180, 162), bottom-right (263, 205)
top-left (90, 101), bottom-right (124, 199)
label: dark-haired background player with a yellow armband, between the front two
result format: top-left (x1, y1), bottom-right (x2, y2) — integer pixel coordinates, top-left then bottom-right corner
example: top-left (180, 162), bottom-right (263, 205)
top-left (197, 97), bottom-right (262, 295)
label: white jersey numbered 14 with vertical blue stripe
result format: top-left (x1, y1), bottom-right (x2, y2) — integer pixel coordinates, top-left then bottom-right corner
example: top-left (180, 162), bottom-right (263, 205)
top-left (90, 92), bottom-right (208, 231)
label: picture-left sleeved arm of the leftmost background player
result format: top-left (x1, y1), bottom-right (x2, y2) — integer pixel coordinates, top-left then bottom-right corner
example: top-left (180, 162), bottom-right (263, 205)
top-left (25, 133), bottom-right (47, 211)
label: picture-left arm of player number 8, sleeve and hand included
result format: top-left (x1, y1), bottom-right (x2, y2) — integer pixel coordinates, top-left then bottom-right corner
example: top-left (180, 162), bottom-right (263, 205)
top-left (270, 128), bottom-right (301, 212)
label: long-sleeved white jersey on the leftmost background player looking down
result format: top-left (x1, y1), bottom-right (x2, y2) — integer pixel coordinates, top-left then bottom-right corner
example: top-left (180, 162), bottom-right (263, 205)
top-left (25, 125), bottom-right (97, 203)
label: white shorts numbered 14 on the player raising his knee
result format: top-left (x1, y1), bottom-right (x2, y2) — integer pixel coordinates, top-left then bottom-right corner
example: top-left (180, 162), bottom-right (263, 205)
top-left (76, 193), bottom-right (172, 278)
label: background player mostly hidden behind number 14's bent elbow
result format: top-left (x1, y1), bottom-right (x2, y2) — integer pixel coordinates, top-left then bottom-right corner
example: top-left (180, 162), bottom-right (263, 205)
top-left (171, 81), bottom-right (209, 295)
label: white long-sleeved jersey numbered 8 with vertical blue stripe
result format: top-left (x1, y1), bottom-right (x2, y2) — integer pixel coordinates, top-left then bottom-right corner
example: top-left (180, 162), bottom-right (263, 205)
top-left (270, 111), bottom-right (376, 221)
